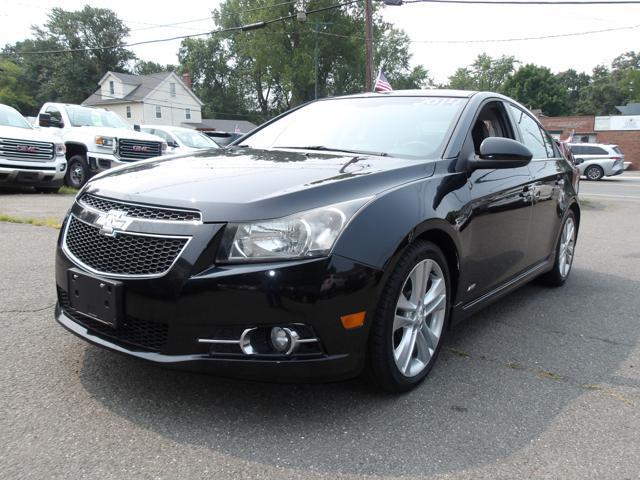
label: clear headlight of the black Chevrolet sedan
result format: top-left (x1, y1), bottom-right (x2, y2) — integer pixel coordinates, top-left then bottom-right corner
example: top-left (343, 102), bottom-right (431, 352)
top-left (218, 197), bottom-right (371, 262)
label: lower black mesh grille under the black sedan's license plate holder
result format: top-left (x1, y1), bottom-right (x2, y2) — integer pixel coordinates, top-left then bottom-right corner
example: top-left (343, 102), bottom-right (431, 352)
top-left (58, 288), bottom-right (169, 352)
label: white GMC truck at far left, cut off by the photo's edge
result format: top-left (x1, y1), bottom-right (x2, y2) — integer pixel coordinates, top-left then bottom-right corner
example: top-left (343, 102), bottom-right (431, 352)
top-left (0, 104), bottom-right (67, 193)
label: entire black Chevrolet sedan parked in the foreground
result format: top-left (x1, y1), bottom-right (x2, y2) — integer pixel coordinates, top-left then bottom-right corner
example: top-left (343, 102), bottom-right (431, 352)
top-left (55, 90), bottom-right (580, 392)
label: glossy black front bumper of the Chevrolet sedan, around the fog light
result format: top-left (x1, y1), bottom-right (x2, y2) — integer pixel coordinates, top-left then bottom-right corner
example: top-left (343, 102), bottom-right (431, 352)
top-left (55, 242), bottom-right (382, 381)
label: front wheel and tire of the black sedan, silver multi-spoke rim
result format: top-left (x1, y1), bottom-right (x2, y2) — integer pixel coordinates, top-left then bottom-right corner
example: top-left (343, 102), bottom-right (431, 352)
top-left (367, 241), bottom-right (451, 393)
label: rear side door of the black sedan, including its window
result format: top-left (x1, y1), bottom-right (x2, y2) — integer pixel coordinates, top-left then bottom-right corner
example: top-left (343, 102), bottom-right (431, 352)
top-left (509, 104), bottom-right (573, 265)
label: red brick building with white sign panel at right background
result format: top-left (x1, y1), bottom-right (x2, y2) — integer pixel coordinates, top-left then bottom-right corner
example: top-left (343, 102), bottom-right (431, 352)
top-left (539, 115), bottom-right (640, 170)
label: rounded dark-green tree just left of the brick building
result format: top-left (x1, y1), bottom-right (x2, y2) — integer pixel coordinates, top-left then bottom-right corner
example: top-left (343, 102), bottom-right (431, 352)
top-left (504, 64), bottom-right (568, 116)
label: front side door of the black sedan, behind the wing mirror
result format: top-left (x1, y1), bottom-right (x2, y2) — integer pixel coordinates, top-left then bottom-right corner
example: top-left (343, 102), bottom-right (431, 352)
top-left (463, 100), bottom-right (532, 299)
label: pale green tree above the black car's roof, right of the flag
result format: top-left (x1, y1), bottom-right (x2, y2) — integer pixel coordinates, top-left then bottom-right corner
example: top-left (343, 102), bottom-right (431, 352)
top-left (448, 53), bottom-right (518, 92)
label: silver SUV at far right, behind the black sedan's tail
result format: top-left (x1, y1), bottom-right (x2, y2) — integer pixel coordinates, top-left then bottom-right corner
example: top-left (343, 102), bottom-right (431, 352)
top-left (569, 143), bottom-right (624, 180)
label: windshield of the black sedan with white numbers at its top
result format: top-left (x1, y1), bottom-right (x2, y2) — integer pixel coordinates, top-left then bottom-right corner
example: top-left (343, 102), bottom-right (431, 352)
top-left (242, 95), bottom-right (467, 158)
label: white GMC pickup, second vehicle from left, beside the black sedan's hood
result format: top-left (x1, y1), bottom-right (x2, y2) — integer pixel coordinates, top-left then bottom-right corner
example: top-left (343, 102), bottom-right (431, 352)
top-left (38, 103), bottom-right (167, 188)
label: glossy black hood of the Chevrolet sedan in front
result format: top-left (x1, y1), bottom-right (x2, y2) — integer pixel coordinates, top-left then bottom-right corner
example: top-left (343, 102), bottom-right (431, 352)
top-left (86, 148), bottom-right (435, 222)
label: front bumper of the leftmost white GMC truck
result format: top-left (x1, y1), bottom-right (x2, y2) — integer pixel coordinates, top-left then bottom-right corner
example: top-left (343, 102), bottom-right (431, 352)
top-left (0, 156), bottom-right (67, 187)
